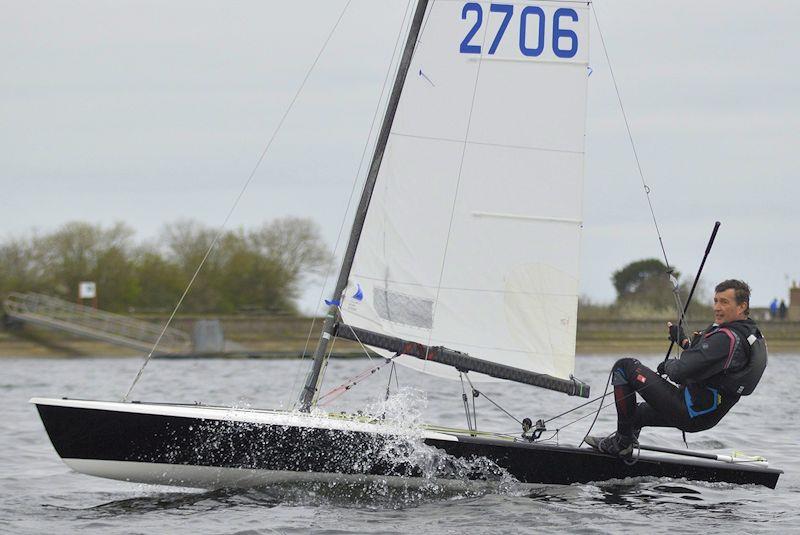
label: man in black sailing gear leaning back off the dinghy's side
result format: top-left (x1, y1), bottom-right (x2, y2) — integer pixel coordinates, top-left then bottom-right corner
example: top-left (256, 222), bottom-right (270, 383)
top-left (585, 280), bottom-right (767, 458)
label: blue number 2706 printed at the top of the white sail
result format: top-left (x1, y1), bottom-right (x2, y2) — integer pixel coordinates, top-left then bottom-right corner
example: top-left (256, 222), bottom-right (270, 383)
top-left (460, 2), bottom-right (578, 58)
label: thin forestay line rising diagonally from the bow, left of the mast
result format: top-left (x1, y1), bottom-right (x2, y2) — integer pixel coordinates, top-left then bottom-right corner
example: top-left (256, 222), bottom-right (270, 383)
top-left (122, 0), bottom-right (352, 401)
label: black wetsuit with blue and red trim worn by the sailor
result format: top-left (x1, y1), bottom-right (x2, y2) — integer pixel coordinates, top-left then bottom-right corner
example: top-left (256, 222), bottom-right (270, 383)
top-left (612, 318), bottom-right (760, 436)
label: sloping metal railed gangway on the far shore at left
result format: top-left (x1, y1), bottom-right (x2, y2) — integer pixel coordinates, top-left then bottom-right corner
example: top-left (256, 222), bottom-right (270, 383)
top-left (3, 292), bottom-right (192, 353)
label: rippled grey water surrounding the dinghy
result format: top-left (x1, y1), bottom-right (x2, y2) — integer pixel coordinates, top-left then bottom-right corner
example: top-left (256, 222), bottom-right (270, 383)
top-left (0, 355), bottom-right (800, 534)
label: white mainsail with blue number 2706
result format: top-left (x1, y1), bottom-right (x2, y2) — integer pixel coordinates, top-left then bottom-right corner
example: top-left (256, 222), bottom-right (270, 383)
top-left (342, 0), bottom-right (589, 379)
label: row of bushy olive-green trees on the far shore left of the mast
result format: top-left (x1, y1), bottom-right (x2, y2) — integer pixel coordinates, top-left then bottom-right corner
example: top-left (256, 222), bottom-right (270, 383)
top-left (0, 217), bottom-right (331, 314)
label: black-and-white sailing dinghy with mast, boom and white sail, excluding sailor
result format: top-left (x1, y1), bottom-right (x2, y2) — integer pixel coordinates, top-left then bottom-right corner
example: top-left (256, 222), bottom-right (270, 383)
top-left (31, 0), bottom-right (781, 488)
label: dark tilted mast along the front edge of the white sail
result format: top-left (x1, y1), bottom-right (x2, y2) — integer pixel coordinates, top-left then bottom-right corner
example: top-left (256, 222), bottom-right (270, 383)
top-left (300, 0), bottom-right (428, 411)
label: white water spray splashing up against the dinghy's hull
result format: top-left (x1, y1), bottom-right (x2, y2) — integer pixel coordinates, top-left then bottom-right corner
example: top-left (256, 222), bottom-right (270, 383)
top-left (120, 388), bottom-right (522, 507)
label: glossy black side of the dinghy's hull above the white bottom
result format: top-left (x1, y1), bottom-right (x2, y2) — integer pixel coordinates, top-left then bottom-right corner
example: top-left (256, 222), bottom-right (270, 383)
top-left (37, 404), bottom-right (781, 488)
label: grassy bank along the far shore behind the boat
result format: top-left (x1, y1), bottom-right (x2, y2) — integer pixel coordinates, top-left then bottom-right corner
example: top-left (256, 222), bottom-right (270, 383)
top-left (0, 316), bottom-right (800, 358)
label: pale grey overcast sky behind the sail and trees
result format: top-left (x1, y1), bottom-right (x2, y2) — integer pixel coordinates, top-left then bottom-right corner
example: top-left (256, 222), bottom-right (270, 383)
top-left (0, 0), bottom-right (800, 311)
